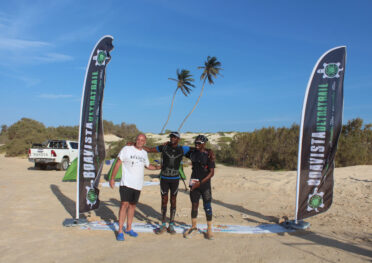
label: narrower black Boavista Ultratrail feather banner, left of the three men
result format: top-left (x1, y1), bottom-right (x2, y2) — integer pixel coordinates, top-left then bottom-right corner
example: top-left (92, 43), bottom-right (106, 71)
top-left (76, 36), bottom-right (113, 218)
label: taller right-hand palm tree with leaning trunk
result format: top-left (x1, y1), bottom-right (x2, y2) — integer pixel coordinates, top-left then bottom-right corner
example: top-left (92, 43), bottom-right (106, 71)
top-left (178, 56), bottom-right (222, 132)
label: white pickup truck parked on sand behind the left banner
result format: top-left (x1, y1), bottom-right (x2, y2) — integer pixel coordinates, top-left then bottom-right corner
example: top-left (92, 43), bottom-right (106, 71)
top-left (28, 140), bottom-right (79, 171)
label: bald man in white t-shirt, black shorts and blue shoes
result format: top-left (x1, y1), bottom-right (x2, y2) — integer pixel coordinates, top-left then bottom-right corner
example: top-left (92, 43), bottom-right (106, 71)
top-left (110, 134), bottom-right (160, 241)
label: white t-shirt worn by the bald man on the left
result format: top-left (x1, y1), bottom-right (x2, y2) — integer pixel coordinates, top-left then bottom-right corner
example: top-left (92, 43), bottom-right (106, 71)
top-left (118, 146), bottom-right (150, 190)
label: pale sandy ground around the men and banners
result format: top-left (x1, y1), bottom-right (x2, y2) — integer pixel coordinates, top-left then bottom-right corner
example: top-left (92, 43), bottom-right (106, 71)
top-left (0, 155), bottom-right (372, 263)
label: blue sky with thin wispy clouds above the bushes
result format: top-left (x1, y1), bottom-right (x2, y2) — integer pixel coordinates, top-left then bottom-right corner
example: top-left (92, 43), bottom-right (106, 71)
top-left (0, 0), bottom-right (372, 133)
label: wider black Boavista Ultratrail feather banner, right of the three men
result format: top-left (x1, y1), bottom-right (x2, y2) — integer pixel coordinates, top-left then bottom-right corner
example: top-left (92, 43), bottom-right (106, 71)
top-left (296, 47), bottom-right (346, 220)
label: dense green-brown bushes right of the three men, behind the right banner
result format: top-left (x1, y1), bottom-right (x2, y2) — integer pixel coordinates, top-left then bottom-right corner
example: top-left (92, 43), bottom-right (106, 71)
top-left (215, 118), bottom-right (372, 170)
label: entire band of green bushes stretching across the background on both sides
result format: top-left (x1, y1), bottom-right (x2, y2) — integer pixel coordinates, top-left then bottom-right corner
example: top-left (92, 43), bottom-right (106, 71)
top-left (0, 118), bottom-right (372, 170)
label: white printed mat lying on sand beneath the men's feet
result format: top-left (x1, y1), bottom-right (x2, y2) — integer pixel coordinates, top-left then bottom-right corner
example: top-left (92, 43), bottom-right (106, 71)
top-left (80, 221), bottom-right (295, 234)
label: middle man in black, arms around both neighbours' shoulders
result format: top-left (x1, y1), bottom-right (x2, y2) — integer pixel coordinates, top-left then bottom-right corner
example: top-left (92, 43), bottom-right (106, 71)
top-left (143, 132), bottom-right (190, 234)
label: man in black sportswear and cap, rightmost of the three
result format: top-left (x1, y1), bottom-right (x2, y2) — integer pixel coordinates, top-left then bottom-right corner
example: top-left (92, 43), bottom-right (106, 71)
top-left (184, 135), bottom-right (216, 239)
